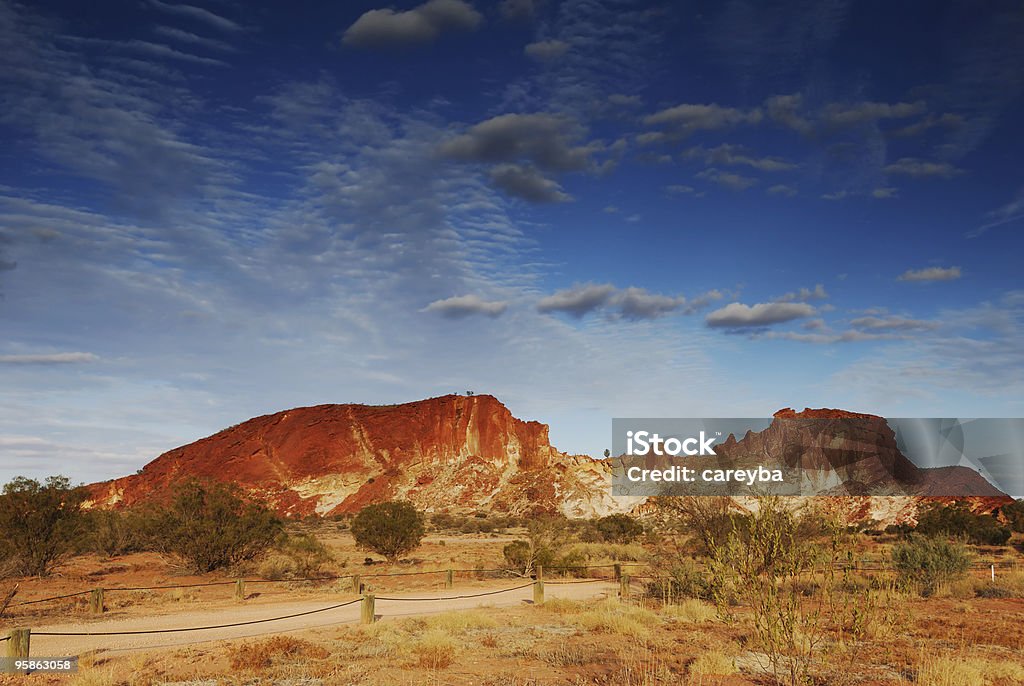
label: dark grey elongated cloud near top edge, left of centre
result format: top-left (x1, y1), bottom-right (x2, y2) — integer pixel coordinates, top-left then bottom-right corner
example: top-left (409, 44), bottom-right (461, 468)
top-left (341, 0), bottom-right (483, 48)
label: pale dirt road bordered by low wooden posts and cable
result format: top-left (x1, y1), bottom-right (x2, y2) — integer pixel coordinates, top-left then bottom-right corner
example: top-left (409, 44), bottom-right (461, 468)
top-left (24, 581), bottom-right (617, 657)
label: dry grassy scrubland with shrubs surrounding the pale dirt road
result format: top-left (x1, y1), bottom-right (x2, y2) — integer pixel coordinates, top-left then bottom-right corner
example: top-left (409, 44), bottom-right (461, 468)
top-left (0, 479), bottom-right (1024, 686)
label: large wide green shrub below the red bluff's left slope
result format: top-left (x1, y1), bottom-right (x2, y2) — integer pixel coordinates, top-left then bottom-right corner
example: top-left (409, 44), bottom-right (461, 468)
top-left (158, 480), bottom-right (283, 573)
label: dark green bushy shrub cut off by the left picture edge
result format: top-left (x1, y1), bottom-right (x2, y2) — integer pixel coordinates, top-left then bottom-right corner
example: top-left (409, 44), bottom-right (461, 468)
top-left (0, 476), bottom-right (86, 576)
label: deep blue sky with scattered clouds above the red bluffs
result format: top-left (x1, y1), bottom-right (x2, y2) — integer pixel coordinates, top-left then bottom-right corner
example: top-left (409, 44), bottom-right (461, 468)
top-left (0, 0), bottom-right (1024, 480)
